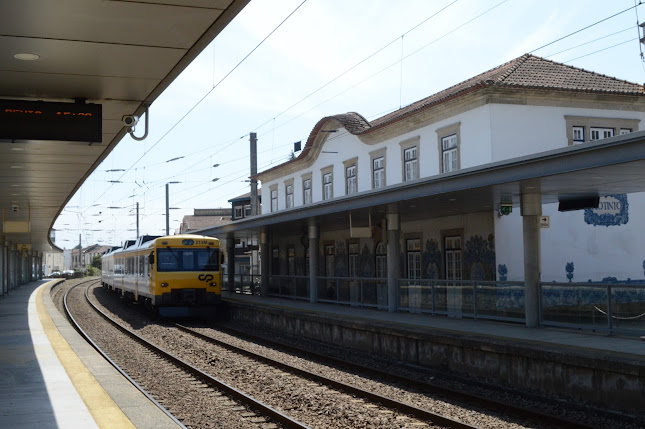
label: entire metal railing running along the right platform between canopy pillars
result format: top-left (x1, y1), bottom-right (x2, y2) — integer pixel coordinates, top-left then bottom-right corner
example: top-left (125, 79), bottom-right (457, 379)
top-left (225, 274), bottom-right (645, 336)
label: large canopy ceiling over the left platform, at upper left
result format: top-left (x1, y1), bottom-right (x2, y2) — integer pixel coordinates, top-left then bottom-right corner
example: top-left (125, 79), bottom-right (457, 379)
top-left (0, 0), bottom-right (250, 252)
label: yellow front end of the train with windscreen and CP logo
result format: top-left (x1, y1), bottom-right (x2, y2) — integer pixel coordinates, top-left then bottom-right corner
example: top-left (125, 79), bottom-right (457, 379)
top-left (150, 235), bottom-right (224, 317)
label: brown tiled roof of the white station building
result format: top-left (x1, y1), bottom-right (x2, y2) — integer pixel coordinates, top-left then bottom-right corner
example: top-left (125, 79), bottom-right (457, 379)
top-left (256, 54), bottom-right (645, 177)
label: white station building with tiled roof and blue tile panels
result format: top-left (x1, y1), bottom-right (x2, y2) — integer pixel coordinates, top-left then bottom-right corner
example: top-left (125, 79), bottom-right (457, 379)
top-left (257, 55), bottom-right (645, 288)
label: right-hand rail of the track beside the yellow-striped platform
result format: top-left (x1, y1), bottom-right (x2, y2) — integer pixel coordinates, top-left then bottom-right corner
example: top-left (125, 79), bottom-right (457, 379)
top-left (80, 287), bottom-right (308, 429)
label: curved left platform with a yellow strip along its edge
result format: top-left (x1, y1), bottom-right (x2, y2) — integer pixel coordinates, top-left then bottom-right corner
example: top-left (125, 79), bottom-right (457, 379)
top-left (0, 280), bottom-right (179, 429)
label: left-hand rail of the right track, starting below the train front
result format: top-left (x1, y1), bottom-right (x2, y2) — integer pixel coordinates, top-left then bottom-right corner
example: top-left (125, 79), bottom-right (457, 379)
top-left (175, 324), bottom-right (477, 429)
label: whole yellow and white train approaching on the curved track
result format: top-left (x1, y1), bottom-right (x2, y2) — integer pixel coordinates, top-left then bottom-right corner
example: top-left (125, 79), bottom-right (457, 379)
top-left (101, 234), bottom-right (224, 317)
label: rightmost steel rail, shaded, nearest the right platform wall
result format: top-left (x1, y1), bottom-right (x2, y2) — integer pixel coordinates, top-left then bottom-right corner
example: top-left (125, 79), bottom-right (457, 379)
top-left (190, 320), bottom-right (604, 429)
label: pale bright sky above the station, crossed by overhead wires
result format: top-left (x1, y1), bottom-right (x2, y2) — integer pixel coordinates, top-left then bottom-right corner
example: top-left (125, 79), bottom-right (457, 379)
top-left (54, 0), bottom-right (645, 249)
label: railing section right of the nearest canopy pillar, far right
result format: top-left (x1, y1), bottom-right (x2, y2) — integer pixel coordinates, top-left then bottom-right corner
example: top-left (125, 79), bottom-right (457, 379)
top-left (540, 282), bottom-right (645, 336)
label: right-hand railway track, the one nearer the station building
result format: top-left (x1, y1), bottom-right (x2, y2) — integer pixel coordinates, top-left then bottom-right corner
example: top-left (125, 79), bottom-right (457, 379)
top-left (65, 280), bottom-right (632, 428)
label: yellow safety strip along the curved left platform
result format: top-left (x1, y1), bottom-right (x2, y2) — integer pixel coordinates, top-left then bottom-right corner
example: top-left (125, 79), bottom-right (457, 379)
top-left (36, 283), bottom-right (135, 428)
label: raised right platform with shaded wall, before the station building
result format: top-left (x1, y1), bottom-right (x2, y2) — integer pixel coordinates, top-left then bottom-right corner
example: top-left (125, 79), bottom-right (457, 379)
top-left (223, 292), bottom-right (645, 412)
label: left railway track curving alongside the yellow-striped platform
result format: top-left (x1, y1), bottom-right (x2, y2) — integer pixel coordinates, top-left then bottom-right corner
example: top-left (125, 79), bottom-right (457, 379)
top-left (64, 282), bottom-right (308, 428)
